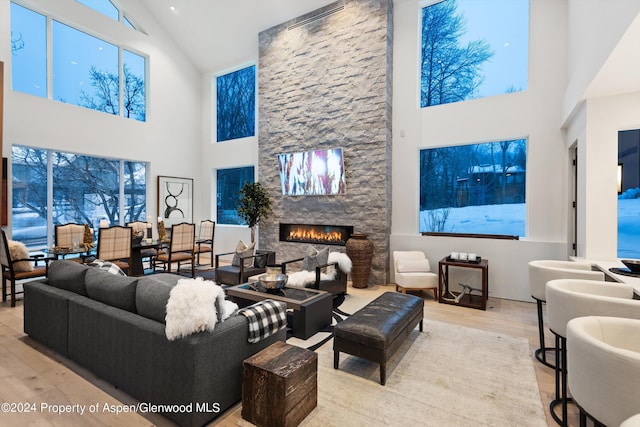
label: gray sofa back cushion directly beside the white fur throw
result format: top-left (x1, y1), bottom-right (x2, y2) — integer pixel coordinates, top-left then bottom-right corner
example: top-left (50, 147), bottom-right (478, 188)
top-left (136, 273), bottom-right (181, 323)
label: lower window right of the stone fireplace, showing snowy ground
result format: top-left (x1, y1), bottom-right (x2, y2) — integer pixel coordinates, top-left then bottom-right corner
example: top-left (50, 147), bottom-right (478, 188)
top-left (419, 139), bottom-right (527, 237)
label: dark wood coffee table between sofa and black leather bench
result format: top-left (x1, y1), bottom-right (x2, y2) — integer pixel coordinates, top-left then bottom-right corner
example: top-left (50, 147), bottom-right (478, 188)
top-left (227, 283), bottom-right (333, 340)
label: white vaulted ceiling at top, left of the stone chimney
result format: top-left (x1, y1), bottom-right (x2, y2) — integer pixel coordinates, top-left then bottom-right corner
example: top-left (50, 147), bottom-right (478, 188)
top-left (136, 0), bottom-right (335, 73)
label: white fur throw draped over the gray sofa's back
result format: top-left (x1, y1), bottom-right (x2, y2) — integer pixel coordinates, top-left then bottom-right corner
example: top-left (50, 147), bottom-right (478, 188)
top-left (165, 277), bottom-right (238, 341)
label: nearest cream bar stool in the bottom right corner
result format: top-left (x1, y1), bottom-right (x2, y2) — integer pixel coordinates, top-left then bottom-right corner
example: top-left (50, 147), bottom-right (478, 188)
top-left (567, 316), bottom-right (640, 426)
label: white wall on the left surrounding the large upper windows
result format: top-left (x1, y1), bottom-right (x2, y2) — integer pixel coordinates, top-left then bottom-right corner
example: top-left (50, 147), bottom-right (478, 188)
top-left (0, 0), bottom-right (202, 234)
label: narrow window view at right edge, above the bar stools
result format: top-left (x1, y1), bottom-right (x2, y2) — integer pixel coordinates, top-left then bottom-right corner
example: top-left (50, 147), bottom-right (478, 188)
top-left (617, 129), bottom-right (640, 259)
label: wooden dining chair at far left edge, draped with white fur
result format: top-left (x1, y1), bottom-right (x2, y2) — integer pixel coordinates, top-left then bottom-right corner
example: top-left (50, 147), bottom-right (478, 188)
top-left (0, 230), bottom-right (51, 307)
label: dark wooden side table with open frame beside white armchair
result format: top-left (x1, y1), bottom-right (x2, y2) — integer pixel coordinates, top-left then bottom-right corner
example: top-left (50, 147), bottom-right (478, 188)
top-left (438, 257), bottom-right (489, 310)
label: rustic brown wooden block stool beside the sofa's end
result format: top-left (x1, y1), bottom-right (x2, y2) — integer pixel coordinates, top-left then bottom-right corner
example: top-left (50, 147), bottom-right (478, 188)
top-left (242, 341), bottom-right (318, 427)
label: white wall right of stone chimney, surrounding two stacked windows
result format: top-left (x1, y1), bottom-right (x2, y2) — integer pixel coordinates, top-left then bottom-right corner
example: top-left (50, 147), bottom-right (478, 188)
top-left (391, 0), bottom-right (568, 300)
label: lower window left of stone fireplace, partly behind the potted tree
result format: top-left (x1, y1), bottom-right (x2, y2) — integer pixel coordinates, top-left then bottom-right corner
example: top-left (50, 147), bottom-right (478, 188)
top-left (216, 166), bottom-right (255, 225)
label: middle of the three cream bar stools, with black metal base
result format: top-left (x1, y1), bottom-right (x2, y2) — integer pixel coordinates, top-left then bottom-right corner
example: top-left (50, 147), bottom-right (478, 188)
top-left (547, 279), bottom-right (640, 426)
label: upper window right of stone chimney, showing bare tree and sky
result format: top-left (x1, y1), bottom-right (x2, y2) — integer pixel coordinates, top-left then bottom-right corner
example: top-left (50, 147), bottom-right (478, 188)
top-left (420, 0), bottom-right (529, 107)
